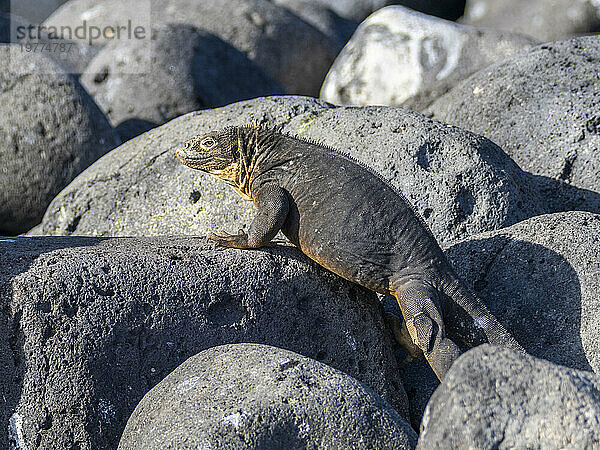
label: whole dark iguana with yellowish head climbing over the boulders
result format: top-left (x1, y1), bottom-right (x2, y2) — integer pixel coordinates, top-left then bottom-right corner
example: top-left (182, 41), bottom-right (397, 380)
top-left (177, 125), bottom-right (523, 380)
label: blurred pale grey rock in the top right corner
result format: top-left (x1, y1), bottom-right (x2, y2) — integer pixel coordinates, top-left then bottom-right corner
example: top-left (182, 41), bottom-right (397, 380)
top-left (463, 0), bottom-right (600, 42)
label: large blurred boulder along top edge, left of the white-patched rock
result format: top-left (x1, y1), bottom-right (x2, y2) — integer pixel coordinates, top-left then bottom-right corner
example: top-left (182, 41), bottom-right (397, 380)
top-left (44, 0), bottom-right (336, 96)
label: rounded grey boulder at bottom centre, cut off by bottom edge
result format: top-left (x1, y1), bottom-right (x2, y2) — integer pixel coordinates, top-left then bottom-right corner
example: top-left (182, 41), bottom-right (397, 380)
top-left (119, 344), bottom-right (417, 450)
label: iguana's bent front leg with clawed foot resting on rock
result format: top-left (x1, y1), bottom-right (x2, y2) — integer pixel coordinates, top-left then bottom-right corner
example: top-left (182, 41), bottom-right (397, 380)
top-left (207, 184), bottom-right (289, 249)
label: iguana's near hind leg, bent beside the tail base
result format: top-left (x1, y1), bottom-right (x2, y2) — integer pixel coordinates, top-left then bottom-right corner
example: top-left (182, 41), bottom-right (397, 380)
top-left (394, 280), bottom-right (461, 380)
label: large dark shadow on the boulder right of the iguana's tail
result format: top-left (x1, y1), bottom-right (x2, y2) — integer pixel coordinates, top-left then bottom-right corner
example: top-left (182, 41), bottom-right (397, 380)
top-left (448, 235), bottom-right (592, 371)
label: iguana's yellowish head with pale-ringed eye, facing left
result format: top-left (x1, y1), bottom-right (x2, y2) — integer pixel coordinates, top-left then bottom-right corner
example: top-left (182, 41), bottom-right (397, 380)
top-left (175, 127), bottom-right (251, 200)
